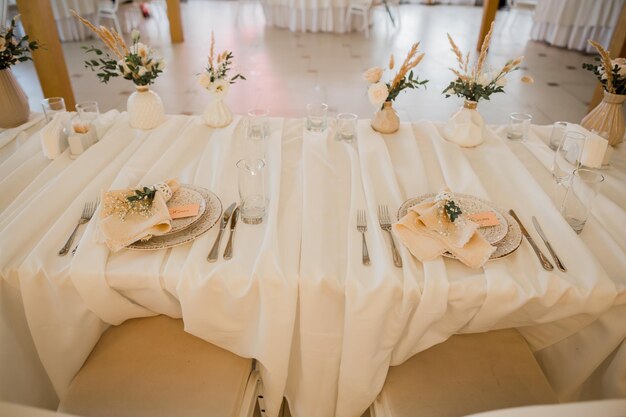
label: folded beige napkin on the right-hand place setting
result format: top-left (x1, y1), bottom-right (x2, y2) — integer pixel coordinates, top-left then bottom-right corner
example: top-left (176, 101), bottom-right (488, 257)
top-left (393, 197), bottom-right (496, 268)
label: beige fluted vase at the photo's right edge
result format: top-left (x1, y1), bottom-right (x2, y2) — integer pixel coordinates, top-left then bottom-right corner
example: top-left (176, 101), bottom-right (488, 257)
top-left (580, 91), bottom-right (626, 146)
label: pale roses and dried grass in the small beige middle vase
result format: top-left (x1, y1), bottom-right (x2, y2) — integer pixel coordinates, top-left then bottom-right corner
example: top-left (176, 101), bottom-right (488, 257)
top-left (363, 42), bottom-right (428, 107)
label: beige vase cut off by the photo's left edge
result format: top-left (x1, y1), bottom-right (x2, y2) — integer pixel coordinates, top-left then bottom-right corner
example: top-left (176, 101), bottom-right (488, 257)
top-left (0, 68), bottom-right (30, 128)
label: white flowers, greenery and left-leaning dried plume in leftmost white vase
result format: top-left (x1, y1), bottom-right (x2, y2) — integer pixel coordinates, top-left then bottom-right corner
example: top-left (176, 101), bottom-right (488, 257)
top-left (71, 10), bottom-right (165, 86)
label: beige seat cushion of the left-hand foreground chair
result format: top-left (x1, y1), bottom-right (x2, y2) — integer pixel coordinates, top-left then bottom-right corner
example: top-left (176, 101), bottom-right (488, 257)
top-left (59, 316), bottom-right (252, 417)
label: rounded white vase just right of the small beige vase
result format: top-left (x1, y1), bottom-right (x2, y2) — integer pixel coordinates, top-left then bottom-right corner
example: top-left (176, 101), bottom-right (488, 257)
top-left (443, 100), bottom-right (485, 148)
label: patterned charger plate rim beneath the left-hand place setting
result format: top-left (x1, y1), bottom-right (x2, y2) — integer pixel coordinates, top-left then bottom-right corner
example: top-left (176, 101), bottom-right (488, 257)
top-left (127, 184), bottom-right (222, 250)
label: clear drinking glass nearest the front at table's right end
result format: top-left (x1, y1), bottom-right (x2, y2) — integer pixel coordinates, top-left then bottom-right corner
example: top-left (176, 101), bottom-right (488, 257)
top-left (561, 168), bottom-right (604, 234)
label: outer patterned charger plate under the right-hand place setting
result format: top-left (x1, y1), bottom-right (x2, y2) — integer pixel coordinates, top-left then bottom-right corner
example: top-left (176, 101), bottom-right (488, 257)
top-left (398, 194), bottom-right (522, 260)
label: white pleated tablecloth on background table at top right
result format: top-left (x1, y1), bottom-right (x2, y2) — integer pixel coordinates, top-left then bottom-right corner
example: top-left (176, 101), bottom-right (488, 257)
top-left (530, 0), bottom-right (624, 52)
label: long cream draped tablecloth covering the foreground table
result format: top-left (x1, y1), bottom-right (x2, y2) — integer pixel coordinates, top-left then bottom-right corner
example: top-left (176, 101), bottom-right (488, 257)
top-left (0, 113), bottom-right (626, 417)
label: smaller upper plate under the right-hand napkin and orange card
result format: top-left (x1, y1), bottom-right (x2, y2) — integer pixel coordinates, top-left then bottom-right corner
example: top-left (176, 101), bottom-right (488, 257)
top-left (398, 194), bottom-right (509, 245)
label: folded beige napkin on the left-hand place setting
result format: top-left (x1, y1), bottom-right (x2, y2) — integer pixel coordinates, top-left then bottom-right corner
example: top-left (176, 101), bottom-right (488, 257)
top-left (98, 179), bottom-right (180, 252)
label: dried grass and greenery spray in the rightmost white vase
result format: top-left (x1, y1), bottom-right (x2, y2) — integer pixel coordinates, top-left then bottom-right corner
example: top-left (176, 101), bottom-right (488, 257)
top-left (442, 23), bottom-right (533, 102)
